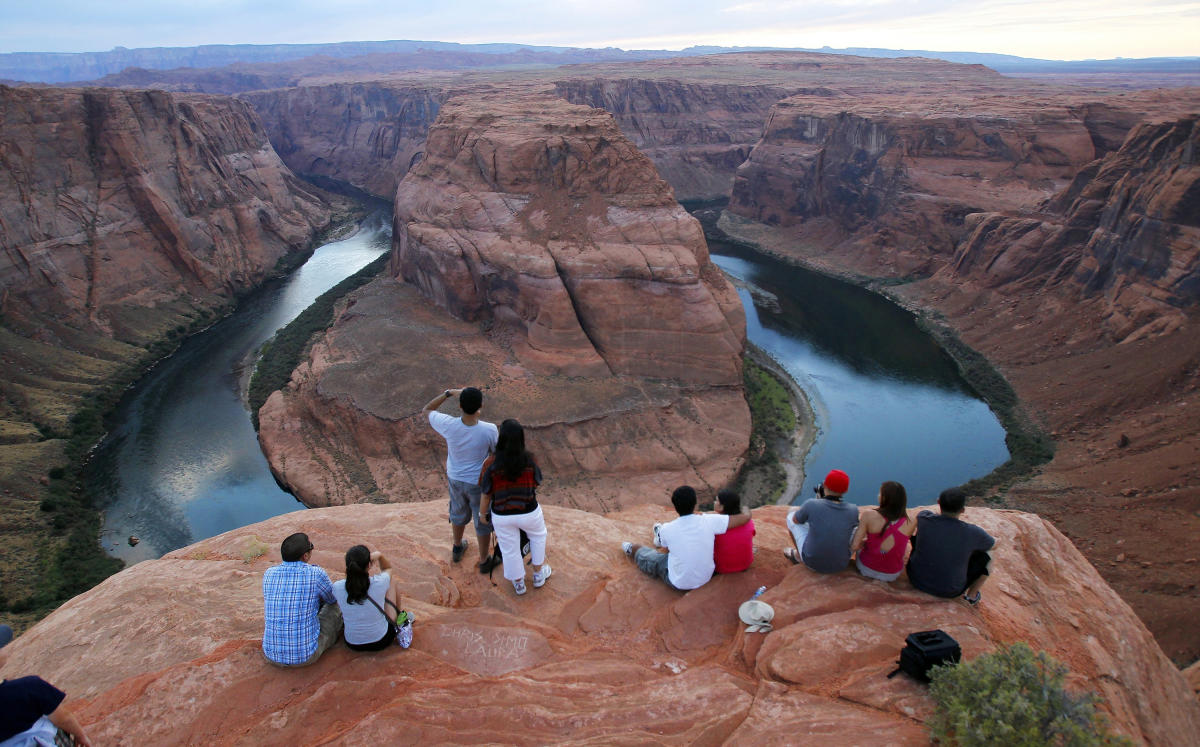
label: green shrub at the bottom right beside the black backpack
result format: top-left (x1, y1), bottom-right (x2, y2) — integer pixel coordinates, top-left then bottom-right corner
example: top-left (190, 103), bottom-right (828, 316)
top-left (929, 643), bottom-right (1132, 747)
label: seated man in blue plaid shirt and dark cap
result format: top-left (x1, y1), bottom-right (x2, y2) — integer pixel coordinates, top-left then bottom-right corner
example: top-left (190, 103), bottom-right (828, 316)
top-left (263, 532), bottom-right (342, 667)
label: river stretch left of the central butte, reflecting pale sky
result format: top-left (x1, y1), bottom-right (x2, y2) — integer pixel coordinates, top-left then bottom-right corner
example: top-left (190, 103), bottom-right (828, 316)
top-left (86, 214), bottom-right (391, 563)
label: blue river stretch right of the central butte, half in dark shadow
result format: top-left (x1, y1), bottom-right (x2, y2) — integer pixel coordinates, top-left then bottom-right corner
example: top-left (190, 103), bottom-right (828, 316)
top-left (708, 239), bottom-right (1008, 506)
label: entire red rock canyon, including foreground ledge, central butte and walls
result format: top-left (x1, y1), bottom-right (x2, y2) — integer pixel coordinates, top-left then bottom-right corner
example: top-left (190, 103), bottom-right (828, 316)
top-left (0, 53), bottom-right (1200, 745)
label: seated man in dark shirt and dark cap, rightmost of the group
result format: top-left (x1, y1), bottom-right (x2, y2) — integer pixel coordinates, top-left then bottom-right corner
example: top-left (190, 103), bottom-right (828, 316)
top-left (908, 488), bottom-right (996, 604)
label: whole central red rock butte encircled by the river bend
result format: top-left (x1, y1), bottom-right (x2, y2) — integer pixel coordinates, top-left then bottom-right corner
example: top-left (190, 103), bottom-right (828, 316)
top-left (259, 95), bottom-right (750, 510)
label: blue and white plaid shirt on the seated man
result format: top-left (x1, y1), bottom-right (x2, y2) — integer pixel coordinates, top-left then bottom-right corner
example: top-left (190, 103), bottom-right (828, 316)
top-left (263, 561), bottom-right (334, 664)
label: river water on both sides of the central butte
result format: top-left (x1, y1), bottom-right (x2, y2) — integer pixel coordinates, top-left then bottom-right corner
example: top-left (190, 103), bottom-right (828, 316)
top-left (88, 207), bottom-right (1008, 563)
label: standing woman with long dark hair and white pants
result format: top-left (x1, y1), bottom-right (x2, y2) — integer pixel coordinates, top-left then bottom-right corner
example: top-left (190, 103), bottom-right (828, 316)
top-left (479, 418), bottom-right (552, 596)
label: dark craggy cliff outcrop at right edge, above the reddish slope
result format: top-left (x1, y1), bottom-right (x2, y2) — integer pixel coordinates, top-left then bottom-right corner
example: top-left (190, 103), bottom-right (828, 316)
top-left (948, 118), bottom-right (1200, 340)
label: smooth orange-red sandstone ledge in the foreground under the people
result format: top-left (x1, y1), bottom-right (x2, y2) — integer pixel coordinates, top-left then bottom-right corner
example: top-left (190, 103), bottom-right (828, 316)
top-left (2, 501), bottom-right (1200, 745)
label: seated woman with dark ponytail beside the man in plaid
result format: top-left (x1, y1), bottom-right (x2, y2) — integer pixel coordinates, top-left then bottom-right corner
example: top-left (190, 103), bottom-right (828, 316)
top-left (334, 545), bottom-right (400, 651)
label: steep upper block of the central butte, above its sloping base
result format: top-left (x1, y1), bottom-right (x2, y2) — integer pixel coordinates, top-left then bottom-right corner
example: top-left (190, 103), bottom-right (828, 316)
top-left (392, 95), bottom-right (745, 386)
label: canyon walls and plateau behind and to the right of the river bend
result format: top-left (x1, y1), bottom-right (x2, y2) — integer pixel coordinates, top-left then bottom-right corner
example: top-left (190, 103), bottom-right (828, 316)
top-left (238, 53), bottom-right (1200, 663)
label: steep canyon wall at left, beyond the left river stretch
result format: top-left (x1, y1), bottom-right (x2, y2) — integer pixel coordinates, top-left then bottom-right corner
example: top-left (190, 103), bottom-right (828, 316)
top-left (0, 81), bottom-right (344, 624)
